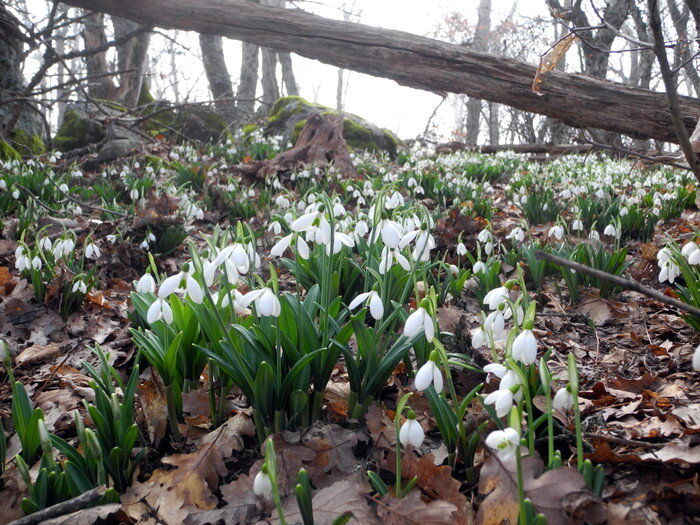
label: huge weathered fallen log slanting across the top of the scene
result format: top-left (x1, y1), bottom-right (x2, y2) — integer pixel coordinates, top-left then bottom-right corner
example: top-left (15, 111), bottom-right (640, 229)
top-left (64, 0), bottom-right (700, 142)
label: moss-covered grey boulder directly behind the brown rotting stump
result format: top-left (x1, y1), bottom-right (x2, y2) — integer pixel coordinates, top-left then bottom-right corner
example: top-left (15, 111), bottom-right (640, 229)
top-left (265, 96), bottom-right (399, 159)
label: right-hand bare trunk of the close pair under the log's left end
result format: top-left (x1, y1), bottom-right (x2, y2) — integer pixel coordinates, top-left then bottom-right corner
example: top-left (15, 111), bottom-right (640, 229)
top-left (112, 16), bottom-right (151, 108)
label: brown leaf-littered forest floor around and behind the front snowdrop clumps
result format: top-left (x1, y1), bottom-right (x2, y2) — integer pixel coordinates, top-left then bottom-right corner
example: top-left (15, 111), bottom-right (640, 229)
top-left (0, 137), bottom-right (700, 524)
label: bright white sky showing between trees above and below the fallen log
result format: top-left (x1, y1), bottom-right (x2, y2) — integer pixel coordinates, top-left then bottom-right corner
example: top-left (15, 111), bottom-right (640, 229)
top-left (151, 0), bottom-right (548, 138)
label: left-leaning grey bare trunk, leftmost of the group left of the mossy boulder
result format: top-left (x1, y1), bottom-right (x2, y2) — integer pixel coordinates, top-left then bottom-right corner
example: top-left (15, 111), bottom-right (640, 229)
top-left (199, 33), bottom-right (236, 122)
